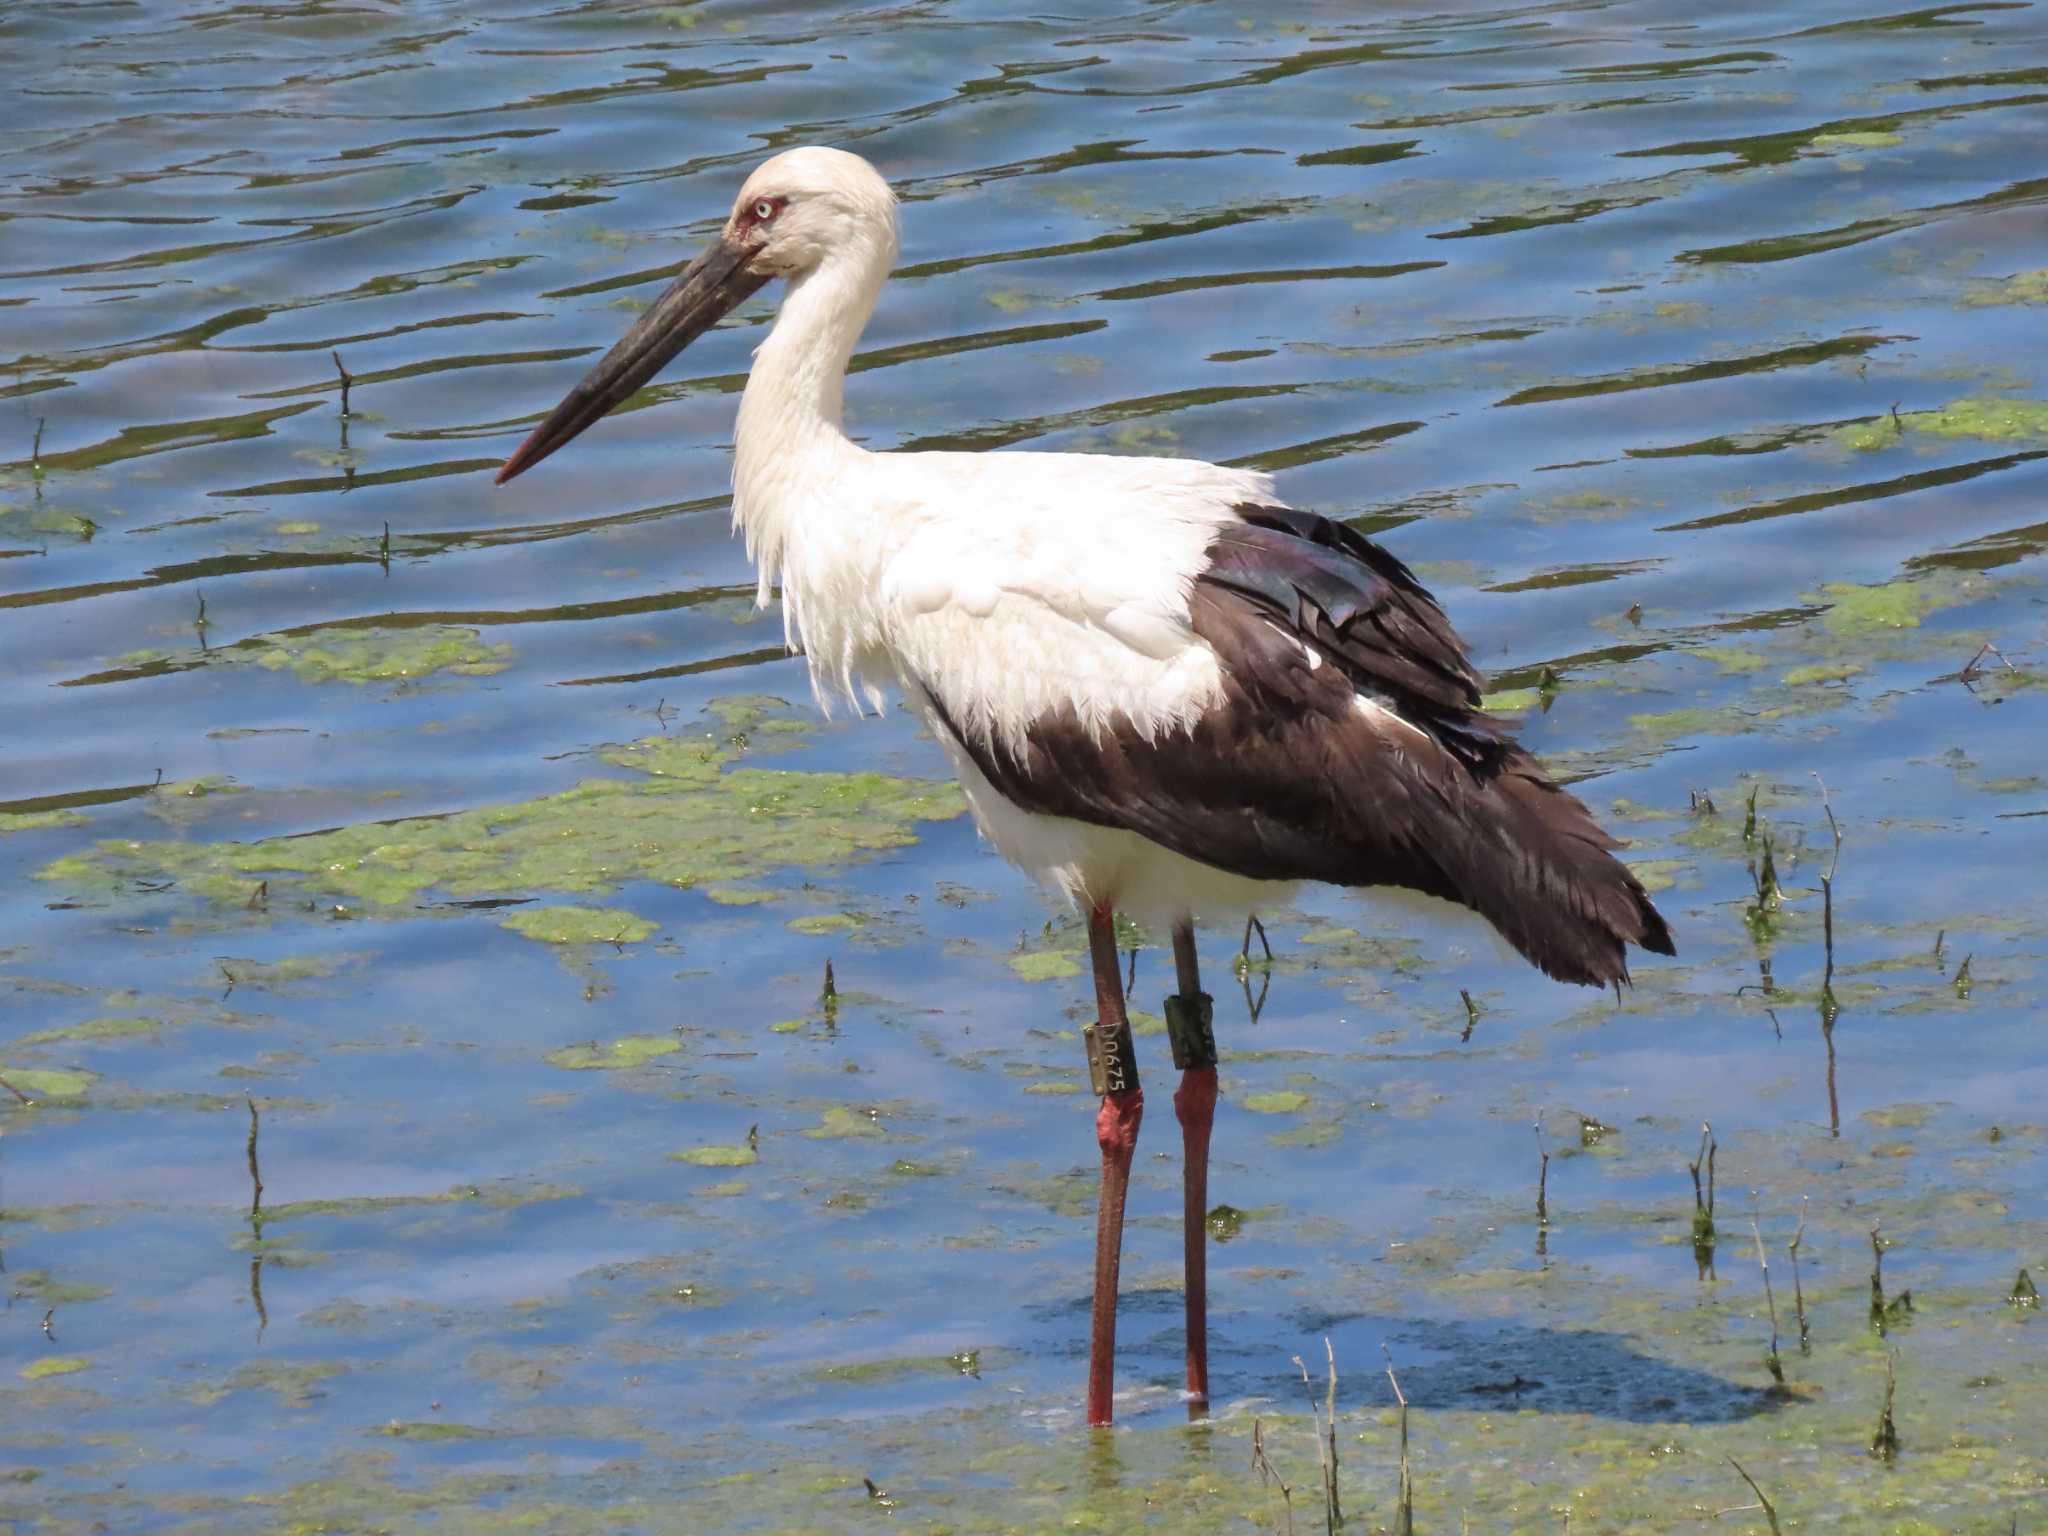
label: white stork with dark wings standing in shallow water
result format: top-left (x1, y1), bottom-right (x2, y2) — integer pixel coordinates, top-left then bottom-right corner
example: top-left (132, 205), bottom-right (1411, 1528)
top-left (498, 147), bottom-right (1673, 1425)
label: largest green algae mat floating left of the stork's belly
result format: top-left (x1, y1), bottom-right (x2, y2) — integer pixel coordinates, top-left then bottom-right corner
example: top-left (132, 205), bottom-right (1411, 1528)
top-left (39, 725), bottom-right (965, 921)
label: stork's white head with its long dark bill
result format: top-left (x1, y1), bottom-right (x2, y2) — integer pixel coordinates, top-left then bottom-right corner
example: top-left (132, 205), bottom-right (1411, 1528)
top-left (498, 145), bottom-right (897, 485)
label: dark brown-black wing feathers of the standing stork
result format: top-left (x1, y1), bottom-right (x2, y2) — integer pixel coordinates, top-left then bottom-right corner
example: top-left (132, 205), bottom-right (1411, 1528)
top-left (932, 506), bottom-right (1673, 985)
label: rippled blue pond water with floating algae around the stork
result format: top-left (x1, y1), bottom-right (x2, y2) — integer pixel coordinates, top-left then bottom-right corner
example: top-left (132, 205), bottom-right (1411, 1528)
top-left (0, 0), bottom-right (2048, 1532)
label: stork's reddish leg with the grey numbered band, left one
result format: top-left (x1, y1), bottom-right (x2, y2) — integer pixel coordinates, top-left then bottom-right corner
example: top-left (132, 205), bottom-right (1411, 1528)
top-left (1081, 907), bottom-right (1145, 1425)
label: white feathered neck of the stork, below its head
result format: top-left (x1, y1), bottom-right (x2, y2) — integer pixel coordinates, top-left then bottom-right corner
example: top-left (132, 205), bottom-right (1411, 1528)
top-left (733, 246), bottom-right (895, 606)
